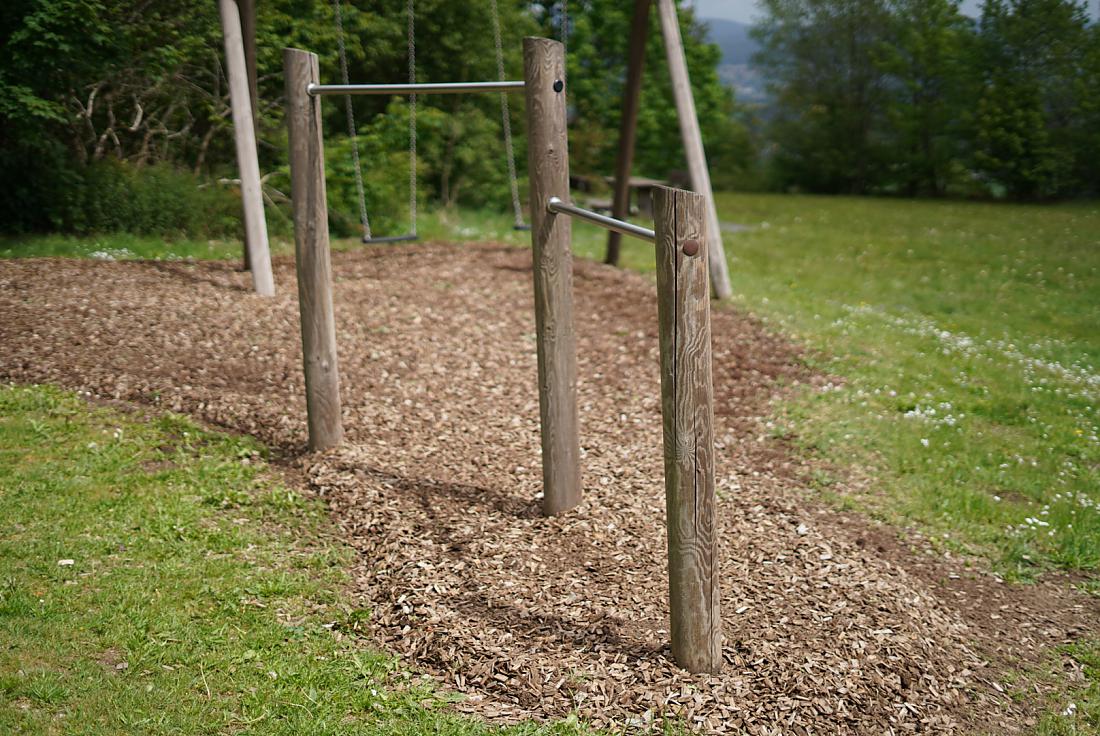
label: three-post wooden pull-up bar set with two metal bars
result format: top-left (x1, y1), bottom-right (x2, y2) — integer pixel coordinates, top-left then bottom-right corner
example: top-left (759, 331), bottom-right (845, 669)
top-left (283, 37), bottom-right (722, 672)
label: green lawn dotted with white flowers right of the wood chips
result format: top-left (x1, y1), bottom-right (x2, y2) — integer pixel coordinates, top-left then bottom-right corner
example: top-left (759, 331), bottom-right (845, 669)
top-left (695, 196), bottom-right (1100, 576)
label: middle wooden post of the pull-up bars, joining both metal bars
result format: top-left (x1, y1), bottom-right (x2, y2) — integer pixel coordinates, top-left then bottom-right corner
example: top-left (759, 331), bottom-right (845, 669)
top-left (524, 39), bottom-right (581, 516)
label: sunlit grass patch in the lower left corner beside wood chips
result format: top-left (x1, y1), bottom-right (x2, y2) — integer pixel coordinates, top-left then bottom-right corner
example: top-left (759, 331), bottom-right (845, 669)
top-left (0, 386), bottom-right (582, 736)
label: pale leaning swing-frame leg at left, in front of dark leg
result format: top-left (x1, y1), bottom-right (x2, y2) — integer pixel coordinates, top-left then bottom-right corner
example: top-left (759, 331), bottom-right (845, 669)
top-left (218, 0), bottom-right (275, 296)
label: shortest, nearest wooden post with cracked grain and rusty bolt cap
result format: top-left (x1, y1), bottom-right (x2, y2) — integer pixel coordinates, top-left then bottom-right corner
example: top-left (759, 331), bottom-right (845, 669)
top-left (653, 187), bottom-right (722, 672)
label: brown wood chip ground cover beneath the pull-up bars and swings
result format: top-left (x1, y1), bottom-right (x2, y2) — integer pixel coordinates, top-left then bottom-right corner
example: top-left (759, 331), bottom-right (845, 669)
top-left (0, 244), bottom-right (1098, 734)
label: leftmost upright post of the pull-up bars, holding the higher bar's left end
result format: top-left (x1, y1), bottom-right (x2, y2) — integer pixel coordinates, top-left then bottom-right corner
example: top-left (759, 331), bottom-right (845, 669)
top-left (283, 48), bottom-right (343, 450)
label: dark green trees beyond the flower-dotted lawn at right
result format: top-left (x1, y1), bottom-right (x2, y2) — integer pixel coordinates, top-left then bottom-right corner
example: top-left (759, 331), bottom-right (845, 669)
top-left (755, 0), bottom-right (1100, 199)
